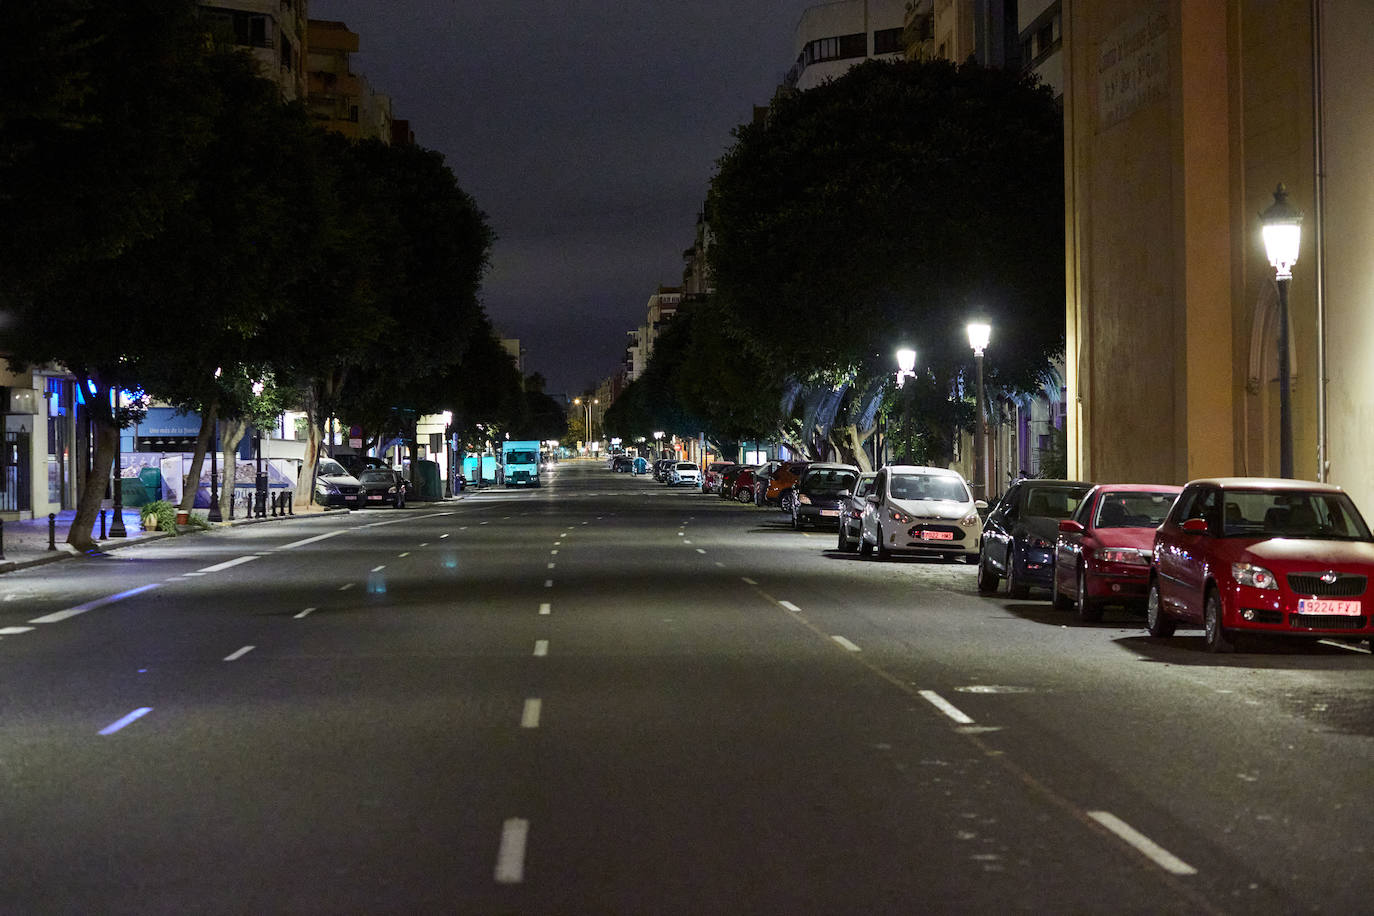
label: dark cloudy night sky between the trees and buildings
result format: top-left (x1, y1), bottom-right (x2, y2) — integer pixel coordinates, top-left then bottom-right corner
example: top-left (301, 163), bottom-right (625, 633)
top-left (309, 0), bottom-right (816, 394)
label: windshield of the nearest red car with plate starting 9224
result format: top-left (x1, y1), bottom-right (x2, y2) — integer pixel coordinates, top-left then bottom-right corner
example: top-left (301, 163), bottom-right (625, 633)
top-left (1221, 490), bottom-right (1374, 541)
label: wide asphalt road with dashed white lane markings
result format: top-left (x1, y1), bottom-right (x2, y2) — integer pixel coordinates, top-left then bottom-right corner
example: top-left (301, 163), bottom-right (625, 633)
top-left (0, 461), bottom-right (1374, 913)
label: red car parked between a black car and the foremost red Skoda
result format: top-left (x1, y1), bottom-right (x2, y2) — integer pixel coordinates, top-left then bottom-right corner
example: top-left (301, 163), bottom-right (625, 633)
top-left (1050, 483), bottom-right (1183, 622)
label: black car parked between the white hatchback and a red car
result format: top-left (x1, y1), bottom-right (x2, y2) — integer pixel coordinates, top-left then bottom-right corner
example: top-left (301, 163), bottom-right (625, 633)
top-left (978, 479), bottom-right (1092, 597)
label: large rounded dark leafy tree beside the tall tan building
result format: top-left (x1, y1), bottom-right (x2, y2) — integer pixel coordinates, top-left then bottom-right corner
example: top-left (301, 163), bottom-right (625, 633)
top-left (709, 60), bottom-right (1063, 463)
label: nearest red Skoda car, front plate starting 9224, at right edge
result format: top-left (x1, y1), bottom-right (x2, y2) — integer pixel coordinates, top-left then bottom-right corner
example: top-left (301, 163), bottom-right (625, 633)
top-left (1146, 478), bottom-right (1374, 652)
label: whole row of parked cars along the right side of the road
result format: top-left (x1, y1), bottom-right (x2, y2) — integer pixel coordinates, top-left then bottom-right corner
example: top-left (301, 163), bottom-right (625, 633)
top-left (701, 461), bottom-right (1374, 652)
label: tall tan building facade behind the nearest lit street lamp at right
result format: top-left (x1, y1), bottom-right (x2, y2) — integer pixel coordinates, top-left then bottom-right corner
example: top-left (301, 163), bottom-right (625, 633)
top-left (1063, 0), bottom-right (1374, 511)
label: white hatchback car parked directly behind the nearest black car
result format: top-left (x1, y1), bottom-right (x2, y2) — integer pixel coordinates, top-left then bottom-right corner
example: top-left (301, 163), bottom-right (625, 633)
top-left (859, 464), bottom-right (988, 563)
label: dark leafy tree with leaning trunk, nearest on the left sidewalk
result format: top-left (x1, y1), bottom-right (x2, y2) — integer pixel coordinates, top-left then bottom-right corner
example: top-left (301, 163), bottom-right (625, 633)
top-left (0, 0), bottom-right (252, 549)
